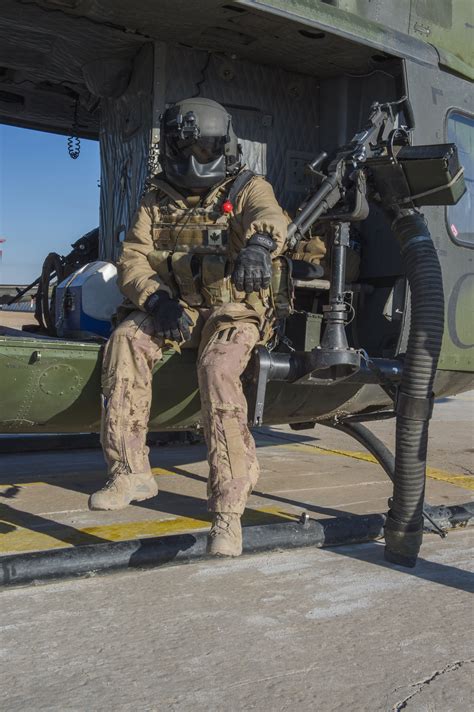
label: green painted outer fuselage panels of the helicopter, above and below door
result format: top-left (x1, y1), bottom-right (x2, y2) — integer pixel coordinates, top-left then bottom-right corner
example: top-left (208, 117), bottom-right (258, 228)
top-left (0, 0), bottom-right (474, 433)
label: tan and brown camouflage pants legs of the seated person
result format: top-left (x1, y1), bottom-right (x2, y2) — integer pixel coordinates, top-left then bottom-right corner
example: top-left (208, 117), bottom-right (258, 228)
top-left (101, 311), bottom-right (260, 514)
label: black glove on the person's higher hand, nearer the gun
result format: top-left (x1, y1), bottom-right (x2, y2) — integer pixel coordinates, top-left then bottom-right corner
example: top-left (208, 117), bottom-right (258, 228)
top-left (231, 232), bottom-right (276, 292)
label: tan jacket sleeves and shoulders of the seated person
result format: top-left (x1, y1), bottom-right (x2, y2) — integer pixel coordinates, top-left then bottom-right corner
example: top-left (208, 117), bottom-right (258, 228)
top-left (117, 176), bottom-right (289, 309)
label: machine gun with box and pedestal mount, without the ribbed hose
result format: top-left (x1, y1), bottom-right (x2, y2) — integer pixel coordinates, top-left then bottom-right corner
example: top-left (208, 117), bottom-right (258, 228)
top-left (252, 97), bottom-right (466, 425)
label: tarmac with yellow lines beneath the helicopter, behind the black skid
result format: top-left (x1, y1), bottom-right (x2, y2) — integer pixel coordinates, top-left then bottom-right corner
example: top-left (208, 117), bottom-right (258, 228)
top-left (0, 393), bottom-right (474, 555)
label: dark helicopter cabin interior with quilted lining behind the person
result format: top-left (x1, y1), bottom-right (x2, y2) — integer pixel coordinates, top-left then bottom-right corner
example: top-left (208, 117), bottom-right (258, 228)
top-left (0, 0), bottom-right (406, 357)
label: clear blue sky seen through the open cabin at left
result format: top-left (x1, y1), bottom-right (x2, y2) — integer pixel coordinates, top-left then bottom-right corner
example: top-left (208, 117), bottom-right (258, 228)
top-left (0, 124), bottom-right (100, 284)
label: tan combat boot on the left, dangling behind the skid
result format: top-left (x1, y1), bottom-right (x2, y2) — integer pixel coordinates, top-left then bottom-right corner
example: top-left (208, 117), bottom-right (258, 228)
top-left (89, 470), bottom-right (158, 509)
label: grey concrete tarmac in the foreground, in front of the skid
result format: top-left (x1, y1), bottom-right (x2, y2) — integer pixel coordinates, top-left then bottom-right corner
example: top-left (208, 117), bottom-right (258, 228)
top-left (0, 530), bottom-right (474, 712)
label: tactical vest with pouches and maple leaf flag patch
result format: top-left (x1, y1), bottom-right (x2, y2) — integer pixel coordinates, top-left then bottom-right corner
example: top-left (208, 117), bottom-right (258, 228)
top-left (147, 174), bottom-right (292, 318)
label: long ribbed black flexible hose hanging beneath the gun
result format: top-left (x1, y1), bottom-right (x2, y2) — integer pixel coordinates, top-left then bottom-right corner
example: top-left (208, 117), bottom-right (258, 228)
top-left (385, 212), bottom-right (444, 567)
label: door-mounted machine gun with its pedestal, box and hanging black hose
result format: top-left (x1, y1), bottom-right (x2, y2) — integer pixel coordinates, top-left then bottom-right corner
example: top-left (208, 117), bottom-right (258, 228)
top-left (253, 98), bottom-right (465, 567)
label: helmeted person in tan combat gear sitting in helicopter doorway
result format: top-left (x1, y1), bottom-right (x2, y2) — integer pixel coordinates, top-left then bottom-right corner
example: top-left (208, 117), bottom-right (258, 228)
top-left (89, 98), bottom-right (288, 556)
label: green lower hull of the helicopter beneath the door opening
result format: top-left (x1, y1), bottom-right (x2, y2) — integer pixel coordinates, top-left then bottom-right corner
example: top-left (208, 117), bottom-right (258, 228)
top-left (0, 336), bottom-right (472, 433)
